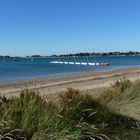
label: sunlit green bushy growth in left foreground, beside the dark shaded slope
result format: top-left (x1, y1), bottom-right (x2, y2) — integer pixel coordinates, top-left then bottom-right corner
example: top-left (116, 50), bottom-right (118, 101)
top-left (1, 90), bottom-right (105, 140)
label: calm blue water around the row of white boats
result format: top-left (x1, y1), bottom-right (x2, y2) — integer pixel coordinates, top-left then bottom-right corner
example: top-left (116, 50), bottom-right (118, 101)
top-left (0, 56), bottom-right (140, 82)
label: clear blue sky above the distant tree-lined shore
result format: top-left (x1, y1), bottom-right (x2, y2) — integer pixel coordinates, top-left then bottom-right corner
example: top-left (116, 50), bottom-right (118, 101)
top-left (0, 0), bottom-right (140, 56)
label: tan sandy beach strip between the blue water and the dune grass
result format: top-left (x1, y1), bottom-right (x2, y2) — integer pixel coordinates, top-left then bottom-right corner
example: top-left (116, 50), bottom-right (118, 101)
top-left (0, 67), bottom-right (140, 97)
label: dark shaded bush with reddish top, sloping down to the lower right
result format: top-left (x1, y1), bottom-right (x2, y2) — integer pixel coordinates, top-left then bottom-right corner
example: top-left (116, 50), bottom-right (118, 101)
top-left (61, 89), bottom-right (140, 140)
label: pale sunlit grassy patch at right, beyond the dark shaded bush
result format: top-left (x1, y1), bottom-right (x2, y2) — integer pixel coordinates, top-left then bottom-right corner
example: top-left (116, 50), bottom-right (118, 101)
top-left (98, 79), bottom-right (140, 121)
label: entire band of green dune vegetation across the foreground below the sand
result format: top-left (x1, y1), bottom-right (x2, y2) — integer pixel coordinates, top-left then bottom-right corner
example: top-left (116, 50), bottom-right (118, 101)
top-left (0, 79), bottom-right (140, 140)
